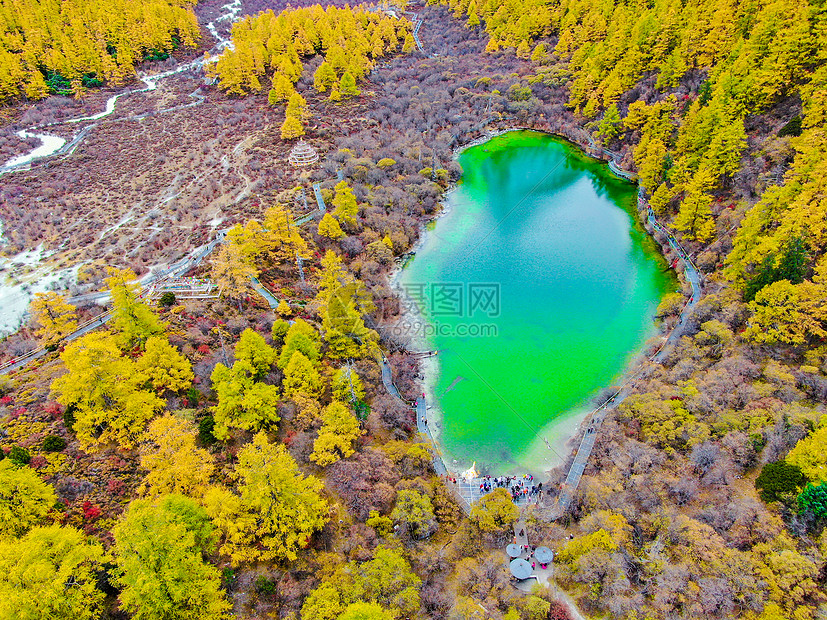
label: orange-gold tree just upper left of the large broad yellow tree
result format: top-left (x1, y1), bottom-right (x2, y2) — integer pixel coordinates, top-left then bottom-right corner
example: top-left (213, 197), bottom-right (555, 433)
top-left (140, 414), bottom-right (215, 496)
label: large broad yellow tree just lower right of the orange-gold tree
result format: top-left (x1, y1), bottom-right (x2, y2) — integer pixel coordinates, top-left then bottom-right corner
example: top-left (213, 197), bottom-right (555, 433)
top-left (204, 433), bottom-right (329, 565)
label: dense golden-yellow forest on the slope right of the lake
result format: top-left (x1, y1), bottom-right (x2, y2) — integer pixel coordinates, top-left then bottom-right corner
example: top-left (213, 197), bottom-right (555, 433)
top-left (450, 0), bottom-right (827, 344)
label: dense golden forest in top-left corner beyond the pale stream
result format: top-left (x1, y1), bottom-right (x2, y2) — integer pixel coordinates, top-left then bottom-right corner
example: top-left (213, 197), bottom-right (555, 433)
top-left (0, 0), bottom-right (201, 102)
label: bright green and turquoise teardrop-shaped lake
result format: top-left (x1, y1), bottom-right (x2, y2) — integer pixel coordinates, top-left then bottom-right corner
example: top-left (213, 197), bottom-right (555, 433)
top-left (399, 131), bottom-right (674, 473)
